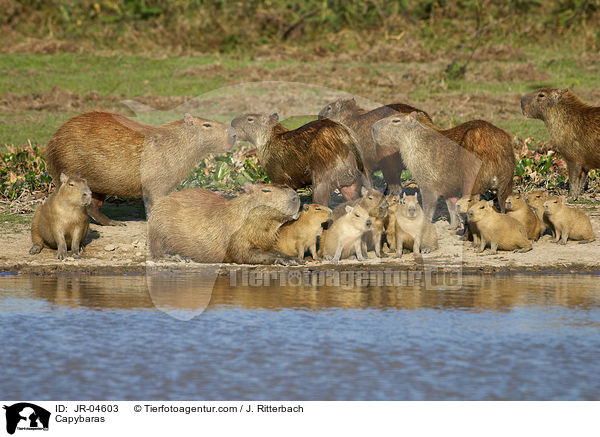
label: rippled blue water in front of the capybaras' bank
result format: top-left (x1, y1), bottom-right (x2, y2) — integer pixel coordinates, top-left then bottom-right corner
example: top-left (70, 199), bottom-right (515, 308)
top-left (0, 275), bottom-right (600, 400)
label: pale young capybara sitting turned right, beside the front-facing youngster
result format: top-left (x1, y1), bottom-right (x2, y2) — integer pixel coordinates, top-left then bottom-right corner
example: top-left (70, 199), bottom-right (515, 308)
top-left (319, 205), bottom-right (371, 263)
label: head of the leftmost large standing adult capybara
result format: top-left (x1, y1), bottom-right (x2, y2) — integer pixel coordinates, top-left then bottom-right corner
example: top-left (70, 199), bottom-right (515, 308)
top-left (183, 114), bottom-right (236, 153)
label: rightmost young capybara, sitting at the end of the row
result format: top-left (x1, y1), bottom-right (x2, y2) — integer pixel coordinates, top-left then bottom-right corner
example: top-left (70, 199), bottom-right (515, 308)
top-left (544, 196), bottom-right (596, 244)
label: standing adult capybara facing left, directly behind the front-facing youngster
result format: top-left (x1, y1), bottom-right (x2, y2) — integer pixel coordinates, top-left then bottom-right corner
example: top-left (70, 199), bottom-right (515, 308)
top-left (373, 113), bottom-right (515, 228)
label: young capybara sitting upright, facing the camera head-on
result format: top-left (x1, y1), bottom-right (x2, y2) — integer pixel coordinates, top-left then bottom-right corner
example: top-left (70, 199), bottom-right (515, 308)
top-left (396, 193), bottom-right (438, 256)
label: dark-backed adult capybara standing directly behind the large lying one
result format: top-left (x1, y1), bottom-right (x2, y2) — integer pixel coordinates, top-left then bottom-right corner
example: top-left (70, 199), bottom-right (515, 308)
top-left (231, 114), bottom-right (371, 206)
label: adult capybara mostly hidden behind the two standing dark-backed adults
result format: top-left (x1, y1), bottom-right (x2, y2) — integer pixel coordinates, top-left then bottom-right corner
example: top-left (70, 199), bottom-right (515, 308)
top-left (319, 99), bottom-right (433, 193)
